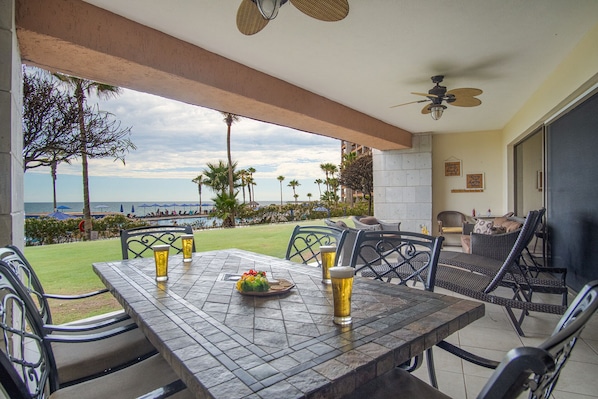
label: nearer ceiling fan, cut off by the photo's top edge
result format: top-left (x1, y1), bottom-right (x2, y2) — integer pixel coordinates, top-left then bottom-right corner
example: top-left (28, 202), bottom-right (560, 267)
top-left (237, 0), bottom-right (349, 35)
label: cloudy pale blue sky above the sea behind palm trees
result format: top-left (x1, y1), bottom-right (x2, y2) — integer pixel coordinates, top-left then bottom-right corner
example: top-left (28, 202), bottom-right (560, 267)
top-left (25, 89), bottom-right (340, 202)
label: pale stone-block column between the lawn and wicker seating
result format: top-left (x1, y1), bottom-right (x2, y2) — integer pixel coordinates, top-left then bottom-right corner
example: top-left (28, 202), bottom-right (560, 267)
top-left (372, 133), bottom-right (436, 235)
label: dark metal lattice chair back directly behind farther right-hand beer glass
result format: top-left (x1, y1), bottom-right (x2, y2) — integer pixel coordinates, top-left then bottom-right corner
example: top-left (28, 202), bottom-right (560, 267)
top-left (285, 226), bottom-right (347, 267)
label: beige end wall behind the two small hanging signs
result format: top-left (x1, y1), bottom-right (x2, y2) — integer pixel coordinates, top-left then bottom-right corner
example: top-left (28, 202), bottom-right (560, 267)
top-left (432, 131), bottom-right (507, 220)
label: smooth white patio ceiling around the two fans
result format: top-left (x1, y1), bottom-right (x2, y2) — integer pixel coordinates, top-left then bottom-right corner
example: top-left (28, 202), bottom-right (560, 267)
top-left (85, 0), bottom-right (598, 133)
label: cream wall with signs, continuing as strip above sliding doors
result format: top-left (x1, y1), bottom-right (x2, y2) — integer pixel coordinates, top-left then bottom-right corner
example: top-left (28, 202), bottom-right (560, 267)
top-left (432, 23), bottom-right (598, 222)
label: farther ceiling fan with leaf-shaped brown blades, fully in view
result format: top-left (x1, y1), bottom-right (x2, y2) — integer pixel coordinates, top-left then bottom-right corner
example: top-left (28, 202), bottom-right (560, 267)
top-left (390, 75), bottom-right (483, 120)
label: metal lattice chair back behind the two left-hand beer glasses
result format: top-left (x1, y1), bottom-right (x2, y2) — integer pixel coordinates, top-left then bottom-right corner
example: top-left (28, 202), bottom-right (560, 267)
top-left (120, 226), bottom-right (195, 259)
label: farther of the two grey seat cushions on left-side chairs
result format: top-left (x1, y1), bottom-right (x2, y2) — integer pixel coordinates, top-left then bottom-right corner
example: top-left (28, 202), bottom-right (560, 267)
top-left (52, 328), bottom-right (155, 384)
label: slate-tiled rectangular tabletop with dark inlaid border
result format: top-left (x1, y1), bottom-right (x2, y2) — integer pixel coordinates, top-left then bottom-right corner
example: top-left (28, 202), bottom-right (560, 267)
top-left (94, 249), bottom-right (484, 399)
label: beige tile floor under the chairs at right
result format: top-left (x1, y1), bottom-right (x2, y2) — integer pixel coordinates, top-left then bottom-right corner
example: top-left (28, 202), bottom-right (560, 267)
top-left (414, 248), bottom-right (598, 399)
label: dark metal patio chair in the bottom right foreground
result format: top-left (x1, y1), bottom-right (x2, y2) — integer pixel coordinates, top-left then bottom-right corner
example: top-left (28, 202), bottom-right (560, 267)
top-left (344, 281), bottom-right (598, 399)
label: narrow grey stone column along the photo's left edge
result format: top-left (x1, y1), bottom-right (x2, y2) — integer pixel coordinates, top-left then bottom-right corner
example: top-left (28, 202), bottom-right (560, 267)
top-left (0, 0), bottom-right (25, 247)
